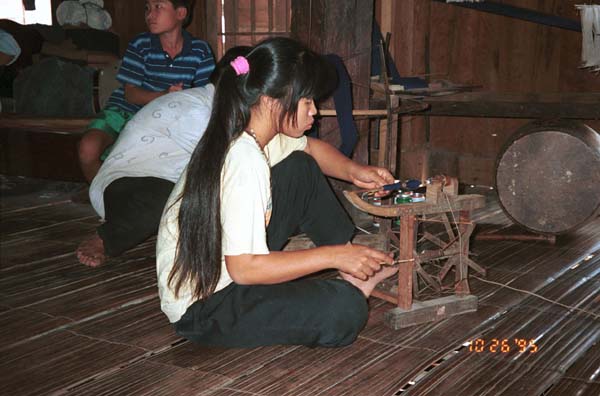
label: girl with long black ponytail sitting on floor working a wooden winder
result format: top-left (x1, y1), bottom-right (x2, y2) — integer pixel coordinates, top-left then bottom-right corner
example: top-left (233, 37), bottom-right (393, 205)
top-left (157, 38), bottom-right (397, 347)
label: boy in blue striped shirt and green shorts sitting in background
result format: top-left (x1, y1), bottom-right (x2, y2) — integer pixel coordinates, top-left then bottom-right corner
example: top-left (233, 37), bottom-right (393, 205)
top-left (79, 0), bottom-right (215, 182)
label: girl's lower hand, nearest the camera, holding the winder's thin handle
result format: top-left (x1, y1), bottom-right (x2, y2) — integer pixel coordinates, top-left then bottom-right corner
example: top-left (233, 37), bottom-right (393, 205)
top-left (333, 242), bottom-right (394, 280)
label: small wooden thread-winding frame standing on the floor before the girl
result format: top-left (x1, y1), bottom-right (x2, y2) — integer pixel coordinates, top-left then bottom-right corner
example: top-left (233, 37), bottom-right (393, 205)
top-left (344, 177), bottom-right (485, 329)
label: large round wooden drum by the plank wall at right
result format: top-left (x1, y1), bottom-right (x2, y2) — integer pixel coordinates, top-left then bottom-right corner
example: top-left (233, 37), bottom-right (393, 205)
top-left (495, 120), bottom-right (600, 234)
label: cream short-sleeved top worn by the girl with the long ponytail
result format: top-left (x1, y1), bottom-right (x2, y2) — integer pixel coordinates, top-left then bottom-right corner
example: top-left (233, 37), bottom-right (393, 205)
top-left (156, 133), bottom-right (307, 323)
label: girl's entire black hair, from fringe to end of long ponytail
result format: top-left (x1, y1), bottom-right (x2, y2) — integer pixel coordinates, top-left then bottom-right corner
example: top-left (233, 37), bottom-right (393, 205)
top-left (169, 37), bottom-right (337, 299)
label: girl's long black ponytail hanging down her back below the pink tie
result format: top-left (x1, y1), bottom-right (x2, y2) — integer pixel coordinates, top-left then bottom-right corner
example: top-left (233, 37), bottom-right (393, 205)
top-left (169, 61), bottom-right (250, 299)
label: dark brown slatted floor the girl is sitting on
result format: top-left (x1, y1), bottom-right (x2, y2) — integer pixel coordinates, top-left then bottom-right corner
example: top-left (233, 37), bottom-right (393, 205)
top-left (0, 176), bottom-right (600, 396)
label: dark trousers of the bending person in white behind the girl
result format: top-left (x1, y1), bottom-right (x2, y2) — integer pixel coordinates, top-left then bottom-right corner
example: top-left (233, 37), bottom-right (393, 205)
top-left (97, 177), bottom-right (174, 256)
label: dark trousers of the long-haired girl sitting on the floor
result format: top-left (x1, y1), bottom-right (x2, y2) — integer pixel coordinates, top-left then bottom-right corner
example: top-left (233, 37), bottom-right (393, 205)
top-left (175, 152), bottom-right (368, 348)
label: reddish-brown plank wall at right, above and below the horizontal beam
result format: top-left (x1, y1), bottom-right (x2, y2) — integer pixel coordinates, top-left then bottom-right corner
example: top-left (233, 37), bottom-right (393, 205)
top-left (376, 0), bottom-right (600, 185)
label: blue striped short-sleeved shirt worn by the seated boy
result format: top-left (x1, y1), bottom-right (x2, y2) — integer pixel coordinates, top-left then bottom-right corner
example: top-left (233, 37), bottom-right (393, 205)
top-left (106, 30), bottom-right (215, 113)
